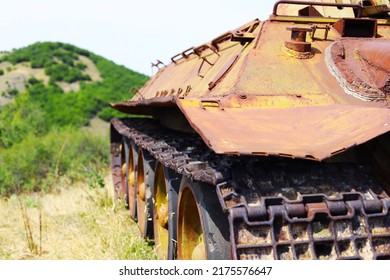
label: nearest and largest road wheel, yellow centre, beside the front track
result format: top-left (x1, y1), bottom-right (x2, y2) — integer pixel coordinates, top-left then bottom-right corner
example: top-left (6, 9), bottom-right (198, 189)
top-left (177, 178), bottom-right (231, 260)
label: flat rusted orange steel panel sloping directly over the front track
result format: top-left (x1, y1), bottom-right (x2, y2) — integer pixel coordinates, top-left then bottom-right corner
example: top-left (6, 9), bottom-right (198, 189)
top-left (177, 102), bottom-right (390, 160)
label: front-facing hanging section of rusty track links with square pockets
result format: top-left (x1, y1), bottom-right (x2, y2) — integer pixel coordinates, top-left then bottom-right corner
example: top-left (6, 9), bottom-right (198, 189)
top-left (218, 184), bottom-right (390, 260)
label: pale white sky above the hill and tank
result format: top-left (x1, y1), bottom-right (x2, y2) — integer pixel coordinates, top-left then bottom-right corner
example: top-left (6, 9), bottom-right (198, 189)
top-left (0, 0), bottom-right (275, 76)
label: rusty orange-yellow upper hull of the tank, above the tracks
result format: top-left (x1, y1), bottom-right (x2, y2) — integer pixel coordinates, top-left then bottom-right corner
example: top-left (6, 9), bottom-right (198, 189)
top-left (112, 1), bottom-right (390, 160)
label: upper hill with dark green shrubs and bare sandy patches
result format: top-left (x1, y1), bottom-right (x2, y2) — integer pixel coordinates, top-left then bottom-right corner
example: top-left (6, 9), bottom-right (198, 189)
top-left (0, 42), bottom-right (148, 124)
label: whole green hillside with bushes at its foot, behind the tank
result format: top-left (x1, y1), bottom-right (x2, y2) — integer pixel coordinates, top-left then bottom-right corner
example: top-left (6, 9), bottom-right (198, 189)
top-left (0, 43), bottom-right (148, 194)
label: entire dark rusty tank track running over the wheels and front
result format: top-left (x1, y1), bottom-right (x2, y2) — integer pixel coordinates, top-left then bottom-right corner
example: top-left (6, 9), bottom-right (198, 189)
top-left (111, 119), bottom-right (390, 259)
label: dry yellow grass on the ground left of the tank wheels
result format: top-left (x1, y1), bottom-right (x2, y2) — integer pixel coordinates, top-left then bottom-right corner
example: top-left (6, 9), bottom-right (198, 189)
top-left (0, 177), bottom-right (155, 260)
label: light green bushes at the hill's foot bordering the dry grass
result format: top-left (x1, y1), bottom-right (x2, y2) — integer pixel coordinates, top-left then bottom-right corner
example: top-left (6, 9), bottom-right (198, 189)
top-left (0, 127), bottom-right (109, 195)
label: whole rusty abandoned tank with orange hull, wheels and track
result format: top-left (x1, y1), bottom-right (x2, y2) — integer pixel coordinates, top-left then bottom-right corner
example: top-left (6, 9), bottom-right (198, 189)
top-left (111, 0), bottom-right (390, 260)
